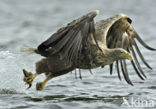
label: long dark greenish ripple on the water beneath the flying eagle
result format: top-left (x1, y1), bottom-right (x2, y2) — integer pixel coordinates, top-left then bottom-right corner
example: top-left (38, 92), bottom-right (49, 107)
top-left (24, 94), bottom-right (131, 103)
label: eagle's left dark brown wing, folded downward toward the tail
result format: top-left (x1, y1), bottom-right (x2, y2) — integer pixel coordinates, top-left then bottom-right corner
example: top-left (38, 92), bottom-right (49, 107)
top-left (38, 10), bottom-right (99, 61)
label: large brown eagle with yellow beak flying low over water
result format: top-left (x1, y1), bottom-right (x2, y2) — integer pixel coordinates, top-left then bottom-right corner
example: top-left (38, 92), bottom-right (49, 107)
top-left (21, 10), bottom-right (156, 91)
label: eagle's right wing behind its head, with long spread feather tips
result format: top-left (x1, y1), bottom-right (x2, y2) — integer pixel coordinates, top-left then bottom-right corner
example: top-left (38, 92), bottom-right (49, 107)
top-left (106, 14), bottom-right (156, 85)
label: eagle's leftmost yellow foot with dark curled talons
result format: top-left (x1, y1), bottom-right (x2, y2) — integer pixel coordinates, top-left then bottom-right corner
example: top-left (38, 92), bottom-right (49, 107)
top-left (23, 69), bottom-right (38, 89)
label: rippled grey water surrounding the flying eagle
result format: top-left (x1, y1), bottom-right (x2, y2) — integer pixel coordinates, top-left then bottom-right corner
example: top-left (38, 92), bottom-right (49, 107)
top-left (0, 0), bottom-right (156, 109)
